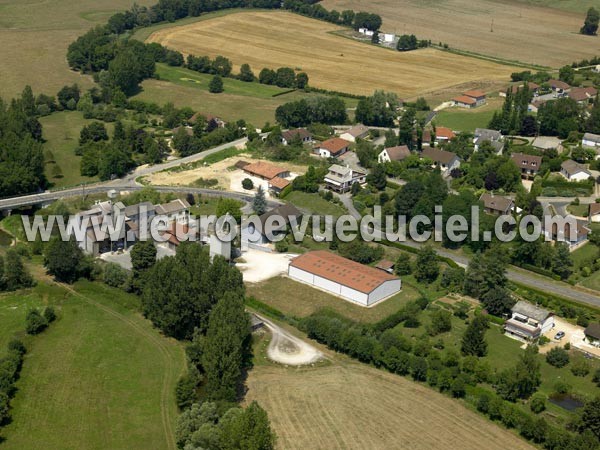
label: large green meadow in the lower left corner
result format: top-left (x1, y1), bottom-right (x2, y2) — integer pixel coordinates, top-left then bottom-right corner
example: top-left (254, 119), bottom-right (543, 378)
top-left (0, 282), bottom-right (185, 449)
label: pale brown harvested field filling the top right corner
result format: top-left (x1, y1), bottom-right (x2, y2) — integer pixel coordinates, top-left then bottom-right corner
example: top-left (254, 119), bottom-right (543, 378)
top-left (322, 0), bottom-right (600, 67)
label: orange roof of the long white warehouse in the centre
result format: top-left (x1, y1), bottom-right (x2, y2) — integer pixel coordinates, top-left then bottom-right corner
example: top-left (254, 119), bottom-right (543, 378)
top-left (290, 250), bottom-right (398, 294)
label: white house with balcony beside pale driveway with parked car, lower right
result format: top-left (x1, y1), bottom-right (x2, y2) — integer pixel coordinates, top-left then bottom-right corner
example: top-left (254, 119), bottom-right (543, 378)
top-left (504, 300), bottom-right (554, 341)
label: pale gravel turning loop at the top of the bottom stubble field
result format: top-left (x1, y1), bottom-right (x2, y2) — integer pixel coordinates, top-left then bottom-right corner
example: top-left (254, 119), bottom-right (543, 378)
top-left (257, 315), bottom-right (324, 366)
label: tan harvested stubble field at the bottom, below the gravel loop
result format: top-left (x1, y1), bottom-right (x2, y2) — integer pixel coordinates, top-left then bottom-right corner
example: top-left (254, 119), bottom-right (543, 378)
top-left (246, 358), bottom-right (533, 450)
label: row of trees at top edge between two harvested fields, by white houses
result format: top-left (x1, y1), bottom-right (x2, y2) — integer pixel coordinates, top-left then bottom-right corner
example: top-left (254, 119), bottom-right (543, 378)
top-left (283, 0), bottom-right (383, 31)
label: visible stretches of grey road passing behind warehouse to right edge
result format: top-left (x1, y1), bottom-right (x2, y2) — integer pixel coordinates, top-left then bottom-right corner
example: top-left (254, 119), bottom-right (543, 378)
top-left (338, 194), bottom-right (600, 307)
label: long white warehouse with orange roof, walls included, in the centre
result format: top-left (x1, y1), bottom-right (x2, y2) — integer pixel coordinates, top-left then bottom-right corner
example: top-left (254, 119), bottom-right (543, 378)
top-left (288, 250), bottom-right (401, 306)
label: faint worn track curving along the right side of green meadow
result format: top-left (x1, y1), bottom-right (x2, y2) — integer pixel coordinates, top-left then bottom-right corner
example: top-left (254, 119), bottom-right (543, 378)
top-left (58, 283), bottom-right (176, 450)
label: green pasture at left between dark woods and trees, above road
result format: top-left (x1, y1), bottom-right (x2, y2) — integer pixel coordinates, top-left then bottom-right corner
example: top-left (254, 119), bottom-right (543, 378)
top-left (40, 111), bottom-right (114, 187)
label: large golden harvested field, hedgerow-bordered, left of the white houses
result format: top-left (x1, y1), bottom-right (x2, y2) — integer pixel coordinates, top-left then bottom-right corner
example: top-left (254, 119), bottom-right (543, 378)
top-left (148, 11), bottom-right (516, 97)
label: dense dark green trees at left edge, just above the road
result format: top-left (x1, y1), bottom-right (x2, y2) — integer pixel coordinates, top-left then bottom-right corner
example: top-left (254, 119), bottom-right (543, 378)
top-left (0, 86), bottom-right (47, 197)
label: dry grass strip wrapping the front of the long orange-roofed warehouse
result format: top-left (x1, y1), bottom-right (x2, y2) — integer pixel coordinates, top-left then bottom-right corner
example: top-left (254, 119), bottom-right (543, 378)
top-left (246, 277), bottom-right (419, 323)
